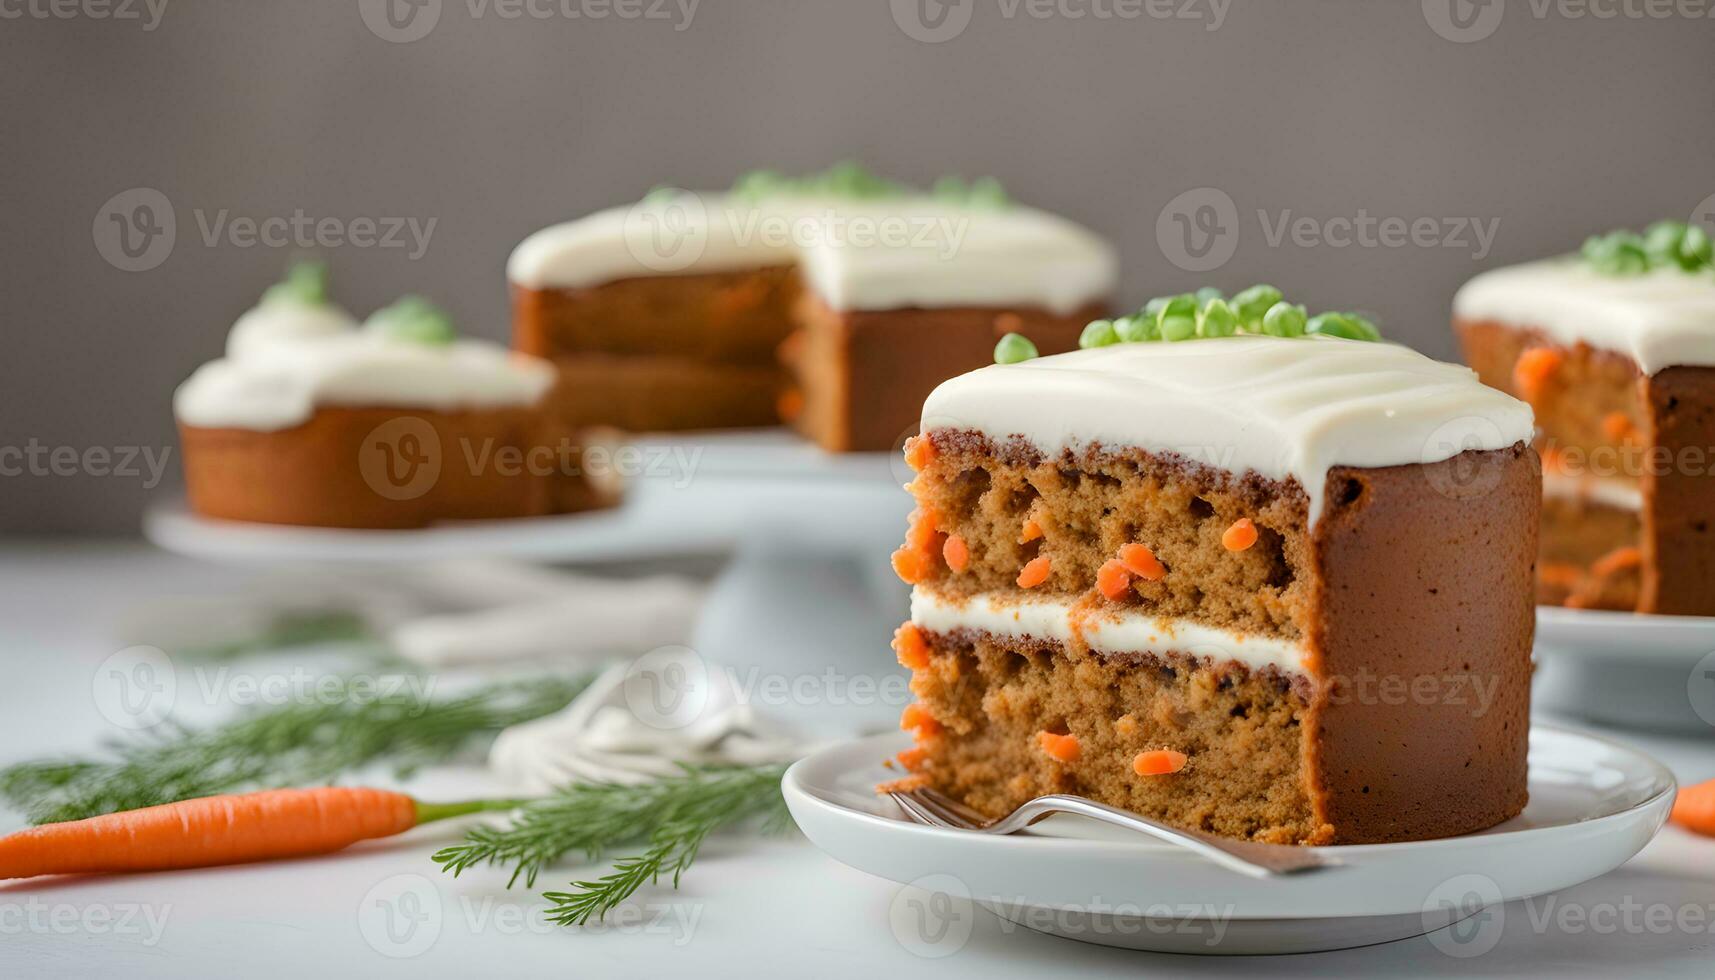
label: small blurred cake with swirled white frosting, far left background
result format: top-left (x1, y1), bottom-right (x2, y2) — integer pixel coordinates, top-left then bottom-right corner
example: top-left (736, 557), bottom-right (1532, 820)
top-left (173, 264), bottom-right (612, 529)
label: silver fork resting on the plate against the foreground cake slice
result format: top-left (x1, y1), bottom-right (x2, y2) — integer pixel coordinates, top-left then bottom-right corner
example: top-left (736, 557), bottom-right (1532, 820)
top-left (888, 789), bottom-right (1339, 879)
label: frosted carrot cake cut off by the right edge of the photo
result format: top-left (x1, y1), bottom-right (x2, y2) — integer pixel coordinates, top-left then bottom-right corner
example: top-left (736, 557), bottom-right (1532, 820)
top-left (1453, 221), bottom-right (1715, 616)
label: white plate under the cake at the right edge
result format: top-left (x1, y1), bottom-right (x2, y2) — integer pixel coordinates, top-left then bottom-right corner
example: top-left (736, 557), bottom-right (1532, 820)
top-left (1535, 606), bottom-right (1715, 735)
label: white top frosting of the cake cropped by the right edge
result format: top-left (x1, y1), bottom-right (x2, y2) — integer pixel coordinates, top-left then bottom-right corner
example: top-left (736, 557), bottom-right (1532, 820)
top-left (1453, 257), bottom-right (1715, 374)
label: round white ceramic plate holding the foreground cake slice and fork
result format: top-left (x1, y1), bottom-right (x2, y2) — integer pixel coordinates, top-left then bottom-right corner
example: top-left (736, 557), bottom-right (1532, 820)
top-left (784, 726), bottom-right (1674, 954)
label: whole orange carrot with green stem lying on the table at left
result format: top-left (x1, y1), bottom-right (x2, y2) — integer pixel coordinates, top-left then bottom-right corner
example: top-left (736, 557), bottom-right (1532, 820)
top-left (0, 786), bottom-right (518, 879)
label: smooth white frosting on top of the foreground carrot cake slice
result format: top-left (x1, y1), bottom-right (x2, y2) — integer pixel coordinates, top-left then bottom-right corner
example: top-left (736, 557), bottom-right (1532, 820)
top-left (923, 336), bottom-right (1533, 525)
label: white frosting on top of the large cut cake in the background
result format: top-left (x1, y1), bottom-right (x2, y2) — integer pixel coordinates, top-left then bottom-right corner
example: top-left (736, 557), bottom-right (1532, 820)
top-left (506, 194), bottom-right (1118, 314)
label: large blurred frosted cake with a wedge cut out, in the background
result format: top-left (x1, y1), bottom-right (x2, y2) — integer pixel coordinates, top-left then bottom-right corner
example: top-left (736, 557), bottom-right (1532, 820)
top-left (508, 165), bottom-right (1115, 451)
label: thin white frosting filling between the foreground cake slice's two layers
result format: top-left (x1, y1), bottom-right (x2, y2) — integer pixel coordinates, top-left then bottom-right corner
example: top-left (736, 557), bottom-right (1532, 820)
top-left (911, 587), bottom-right (1307, 675)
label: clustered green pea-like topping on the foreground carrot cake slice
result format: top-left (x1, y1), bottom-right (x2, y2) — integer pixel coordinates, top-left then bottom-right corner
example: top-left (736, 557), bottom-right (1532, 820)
top-left (1079, 285), bottom-right (1382, 348)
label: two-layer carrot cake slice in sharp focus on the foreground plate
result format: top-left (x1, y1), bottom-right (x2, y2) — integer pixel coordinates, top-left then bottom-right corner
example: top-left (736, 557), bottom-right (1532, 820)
top-left (894, 287), bottom-right (1538, 844)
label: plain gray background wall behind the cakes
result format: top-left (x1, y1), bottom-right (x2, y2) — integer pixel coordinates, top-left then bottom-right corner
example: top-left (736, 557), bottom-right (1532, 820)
top-left (0, 0), bottom-right (1715, 534)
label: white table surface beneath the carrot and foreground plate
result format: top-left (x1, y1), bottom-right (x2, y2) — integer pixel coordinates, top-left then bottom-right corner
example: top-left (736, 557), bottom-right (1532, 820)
top-left (0, 542), bottom-right (1715, 980)
